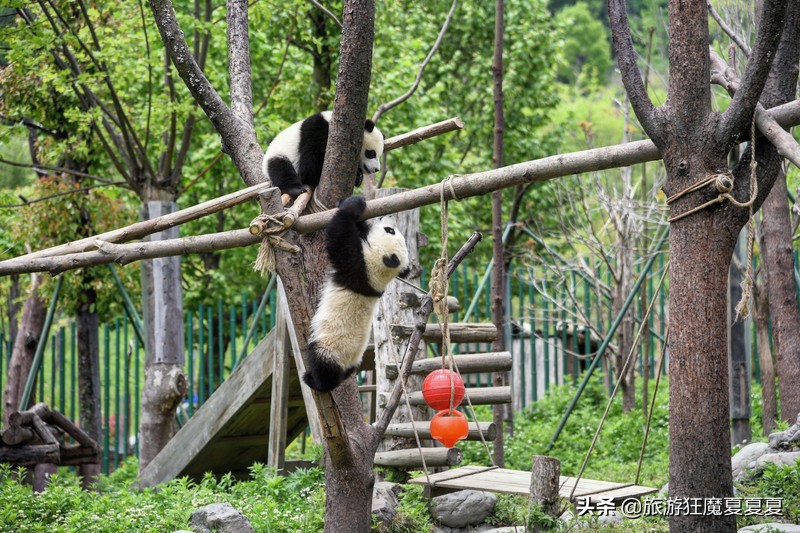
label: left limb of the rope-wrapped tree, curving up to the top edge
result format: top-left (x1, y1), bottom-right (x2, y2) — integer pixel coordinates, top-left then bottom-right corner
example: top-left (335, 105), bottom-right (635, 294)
top-left (608, 0), bottom-right (664, 148)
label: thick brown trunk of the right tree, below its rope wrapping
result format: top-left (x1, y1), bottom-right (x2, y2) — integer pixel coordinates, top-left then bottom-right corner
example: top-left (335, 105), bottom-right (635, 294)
top-left (669, 211), bottom-right (736, 532)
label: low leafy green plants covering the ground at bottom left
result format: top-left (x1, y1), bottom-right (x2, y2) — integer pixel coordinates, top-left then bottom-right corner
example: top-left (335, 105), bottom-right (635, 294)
top-left (0, 461), bottom-right (325, 533)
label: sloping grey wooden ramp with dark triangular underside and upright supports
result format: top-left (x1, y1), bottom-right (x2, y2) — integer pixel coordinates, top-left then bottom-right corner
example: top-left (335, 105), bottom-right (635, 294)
top-left (139, 282), bottom-right (318, 487)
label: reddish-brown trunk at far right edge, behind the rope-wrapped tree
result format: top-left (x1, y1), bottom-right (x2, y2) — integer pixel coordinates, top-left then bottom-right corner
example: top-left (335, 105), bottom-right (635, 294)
top-left (762, 2), bottom-right (800, 424)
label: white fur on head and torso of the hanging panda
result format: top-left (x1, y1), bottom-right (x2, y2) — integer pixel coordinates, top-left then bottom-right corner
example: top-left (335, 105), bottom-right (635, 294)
top-left (309, 217), bottom-right (409, 369)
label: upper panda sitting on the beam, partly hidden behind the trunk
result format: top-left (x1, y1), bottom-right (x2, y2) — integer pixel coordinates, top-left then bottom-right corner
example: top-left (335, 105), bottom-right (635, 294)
top-left (261, 111), bottom-right (383, 204)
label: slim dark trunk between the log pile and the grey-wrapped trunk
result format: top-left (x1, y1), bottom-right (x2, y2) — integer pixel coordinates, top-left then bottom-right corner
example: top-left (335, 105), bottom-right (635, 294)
top-left (77, 277), bottom-right (101, 488)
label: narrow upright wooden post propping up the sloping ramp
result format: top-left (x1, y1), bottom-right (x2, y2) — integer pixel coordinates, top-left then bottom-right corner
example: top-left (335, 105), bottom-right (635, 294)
top-left (267, 305), bottom-right (289, 472)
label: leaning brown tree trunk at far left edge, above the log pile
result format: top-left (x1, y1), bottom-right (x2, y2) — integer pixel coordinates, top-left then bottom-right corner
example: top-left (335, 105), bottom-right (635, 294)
top-left (3, 276), bottom-right (47, 427)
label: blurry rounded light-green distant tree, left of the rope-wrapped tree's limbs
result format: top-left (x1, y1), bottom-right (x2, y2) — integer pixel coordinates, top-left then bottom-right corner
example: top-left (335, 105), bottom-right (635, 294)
top-left (556, 2), bottom-right (612, 87)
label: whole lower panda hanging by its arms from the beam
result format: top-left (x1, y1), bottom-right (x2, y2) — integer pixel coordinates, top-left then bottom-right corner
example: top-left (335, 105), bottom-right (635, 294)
top-left (303, 196), bottom-right (409, 392)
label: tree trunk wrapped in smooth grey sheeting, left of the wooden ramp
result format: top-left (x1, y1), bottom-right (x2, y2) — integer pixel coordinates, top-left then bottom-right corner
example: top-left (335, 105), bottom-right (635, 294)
top-left (139, 200), bottom-right (187, 472)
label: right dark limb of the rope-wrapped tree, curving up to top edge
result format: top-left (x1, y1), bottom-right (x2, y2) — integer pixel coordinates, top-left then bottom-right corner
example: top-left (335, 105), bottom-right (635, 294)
top-left (715, 0), bottom-right (787, 145)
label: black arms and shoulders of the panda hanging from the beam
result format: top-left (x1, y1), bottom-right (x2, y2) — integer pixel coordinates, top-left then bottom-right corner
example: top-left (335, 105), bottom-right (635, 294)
top-left (326, 196), bottom-right (383, 297)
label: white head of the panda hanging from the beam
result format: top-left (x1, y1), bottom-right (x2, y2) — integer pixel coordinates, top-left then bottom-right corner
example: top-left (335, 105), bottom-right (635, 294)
top-left (364, 217), bottom-right (409, 291)
